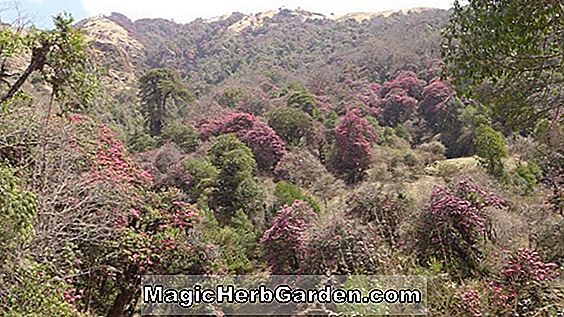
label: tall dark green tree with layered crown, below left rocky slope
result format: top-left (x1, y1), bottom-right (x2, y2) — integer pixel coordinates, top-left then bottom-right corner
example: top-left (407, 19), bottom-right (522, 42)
top-left (139, 68), bottom-right (194, 135)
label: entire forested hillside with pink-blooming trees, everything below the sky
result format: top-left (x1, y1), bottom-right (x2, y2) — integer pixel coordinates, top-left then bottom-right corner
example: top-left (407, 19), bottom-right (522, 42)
top-left (0, 0), bottom-right (564, 317)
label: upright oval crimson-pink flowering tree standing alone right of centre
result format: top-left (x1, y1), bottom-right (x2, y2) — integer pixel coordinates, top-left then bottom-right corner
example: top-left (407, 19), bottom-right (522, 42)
top-left (335, 109), bottom-right (377, 183)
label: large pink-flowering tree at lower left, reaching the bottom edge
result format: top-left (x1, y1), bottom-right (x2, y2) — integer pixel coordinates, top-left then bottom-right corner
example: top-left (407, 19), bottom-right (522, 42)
top-left (64, 116), bottom-right (213, 316)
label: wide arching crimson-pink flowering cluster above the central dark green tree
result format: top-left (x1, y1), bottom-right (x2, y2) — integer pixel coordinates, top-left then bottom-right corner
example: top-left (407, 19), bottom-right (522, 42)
top-left (199, 112), bottom-right (287, 171)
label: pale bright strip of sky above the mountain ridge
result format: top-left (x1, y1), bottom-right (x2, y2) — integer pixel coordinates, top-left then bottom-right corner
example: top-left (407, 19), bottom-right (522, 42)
top-left (0, 0), bottom-right (454, 28)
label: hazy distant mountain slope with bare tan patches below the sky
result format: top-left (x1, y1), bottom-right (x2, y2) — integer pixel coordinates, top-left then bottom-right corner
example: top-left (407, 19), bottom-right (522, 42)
top-left (79, 8), bottom-right (448, 91)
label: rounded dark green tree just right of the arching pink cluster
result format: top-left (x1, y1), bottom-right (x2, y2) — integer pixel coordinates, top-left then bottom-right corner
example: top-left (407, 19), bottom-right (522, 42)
top-left (268, 107), bottom-right (312, 145)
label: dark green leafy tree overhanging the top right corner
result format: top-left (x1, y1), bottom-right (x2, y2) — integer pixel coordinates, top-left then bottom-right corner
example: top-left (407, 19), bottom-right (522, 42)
top-left (443, 0), bottom-right (564, 135)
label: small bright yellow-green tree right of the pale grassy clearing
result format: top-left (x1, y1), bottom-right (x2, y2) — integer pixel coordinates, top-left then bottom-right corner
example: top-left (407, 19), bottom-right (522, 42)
top-left (474, 124), bottom-right (507, 177)
